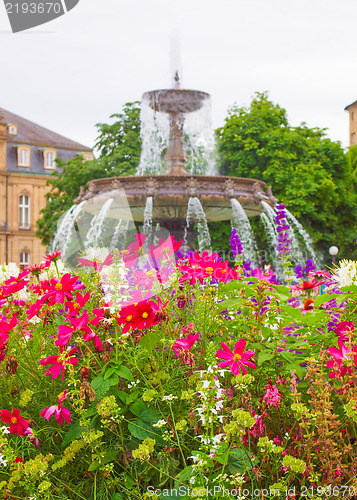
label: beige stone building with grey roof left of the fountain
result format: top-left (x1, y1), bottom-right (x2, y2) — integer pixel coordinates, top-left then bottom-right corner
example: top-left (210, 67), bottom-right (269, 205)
top-left (0, 109), bottom-right (93, 268)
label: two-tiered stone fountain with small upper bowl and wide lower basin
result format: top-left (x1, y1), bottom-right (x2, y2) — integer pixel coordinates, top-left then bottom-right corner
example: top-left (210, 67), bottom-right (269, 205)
top-left (71, 73), bottom-right (277, 259)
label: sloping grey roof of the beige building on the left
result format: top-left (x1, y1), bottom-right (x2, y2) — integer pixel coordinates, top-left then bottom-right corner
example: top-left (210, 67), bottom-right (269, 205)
top-left (0, 108), bottom-right (92, 152)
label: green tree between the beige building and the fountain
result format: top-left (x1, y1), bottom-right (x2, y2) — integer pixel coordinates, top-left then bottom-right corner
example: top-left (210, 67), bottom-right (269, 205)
top-left (36, 101), bottom-right (141, 245)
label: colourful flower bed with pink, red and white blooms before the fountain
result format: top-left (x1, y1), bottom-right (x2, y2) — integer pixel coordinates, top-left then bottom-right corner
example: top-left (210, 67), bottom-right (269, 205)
top-left (0, 234), bottom-right (357, 500)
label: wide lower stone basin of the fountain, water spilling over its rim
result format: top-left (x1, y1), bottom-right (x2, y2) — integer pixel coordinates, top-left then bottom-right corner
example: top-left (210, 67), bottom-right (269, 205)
top-left (76, 175), bottom-right (276, 223)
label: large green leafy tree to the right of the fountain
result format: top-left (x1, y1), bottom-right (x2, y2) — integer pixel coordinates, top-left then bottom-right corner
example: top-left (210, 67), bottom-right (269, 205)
top-left (217, 93), bottom-right (357, 257)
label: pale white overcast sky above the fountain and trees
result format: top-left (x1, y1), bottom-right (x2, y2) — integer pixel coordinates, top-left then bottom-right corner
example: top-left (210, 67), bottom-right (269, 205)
top-left (0, 0), bottom-right (357, 151)
